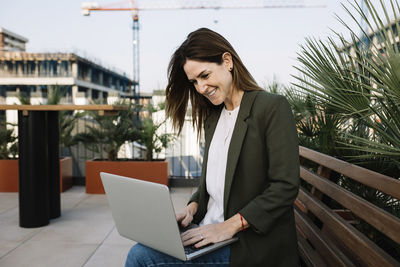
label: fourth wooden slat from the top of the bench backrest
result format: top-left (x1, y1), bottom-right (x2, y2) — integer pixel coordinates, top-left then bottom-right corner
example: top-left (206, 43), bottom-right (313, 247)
top-left (294, 209), bottom-right (354, 267)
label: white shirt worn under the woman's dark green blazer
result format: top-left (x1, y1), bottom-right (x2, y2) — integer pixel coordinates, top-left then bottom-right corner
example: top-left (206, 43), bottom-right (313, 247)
top-left (200, 106), bottom-right (240, 225)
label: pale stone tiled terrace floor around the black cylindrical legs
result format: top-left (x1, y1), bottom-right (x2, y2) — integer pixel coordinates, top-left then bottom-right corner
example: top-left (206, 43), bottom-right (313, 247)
top-left (0, 186), bottom-right (193, 267)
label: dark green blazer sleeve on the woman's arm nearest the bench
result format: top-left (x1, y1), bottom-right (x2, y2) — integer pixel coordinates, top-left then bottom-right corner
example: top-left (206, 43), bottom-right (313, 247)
top-left (240, 96), bottom-right (300, 234)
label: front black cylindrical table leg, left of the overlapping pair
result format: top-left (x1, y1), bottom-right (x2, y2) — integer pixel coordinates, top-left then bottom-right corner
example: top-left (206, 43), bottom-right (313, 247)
top-left (18, 111), bottom-right (50, 228)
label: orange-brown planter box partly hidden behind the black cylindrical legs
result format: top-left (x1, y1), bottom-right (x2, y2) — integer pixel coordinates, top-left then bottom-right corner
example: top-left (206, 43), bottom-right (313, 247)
top-left (0, 157), bottom-right (72, 192)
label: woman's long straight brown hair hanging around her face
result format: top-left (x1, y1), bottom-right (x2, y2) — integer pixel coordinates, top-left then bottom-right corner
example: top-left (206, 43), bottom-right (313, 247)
top-left (166, 28), bottom-right (262, 136)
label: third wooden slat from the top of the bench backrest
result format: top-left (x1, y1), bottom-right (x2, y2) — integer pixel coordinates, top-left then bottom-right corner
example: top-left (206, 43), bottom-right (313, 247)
top-left (298, 189), bottom-right (399, 267)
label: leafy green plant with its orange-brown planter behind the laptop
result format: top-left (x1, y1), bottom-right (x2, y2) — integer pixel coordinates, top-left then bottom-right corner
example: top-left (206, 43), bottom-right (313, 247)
top-left (77, 101), bottom-right (170, 194)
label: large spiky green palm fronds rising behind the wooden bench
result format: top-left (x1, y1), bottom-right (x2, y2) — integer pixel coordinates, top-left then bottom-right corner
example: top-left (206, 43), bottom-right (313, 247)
top-left (296, 0), bottom-right (400, 170)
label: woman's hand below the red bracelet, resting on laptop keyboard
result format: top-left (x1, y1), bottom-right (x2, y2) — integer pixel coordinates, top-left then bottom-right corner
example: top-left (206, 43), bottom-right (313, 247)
top-left (181, 221), bottom-right (237, 248)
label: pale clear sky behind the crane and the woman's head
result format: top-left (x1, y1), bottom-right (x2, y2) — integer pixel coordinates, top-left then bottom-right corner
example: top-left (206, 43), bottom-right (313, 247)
top-left (0, 0), bottom-right (388, 92)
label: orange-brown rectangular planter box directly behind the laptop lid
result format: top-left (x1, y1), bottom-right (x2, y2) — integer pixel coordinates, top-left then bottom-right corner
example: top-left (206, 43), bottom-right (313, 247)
top-left (86, 161), bottom-right (168, 194)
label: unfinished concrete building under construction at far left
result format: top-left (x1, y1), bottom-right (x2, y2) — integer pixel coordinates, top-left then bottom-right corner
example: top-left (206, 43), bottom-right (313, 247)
top-left (0, 26), bottom-right (133, 107)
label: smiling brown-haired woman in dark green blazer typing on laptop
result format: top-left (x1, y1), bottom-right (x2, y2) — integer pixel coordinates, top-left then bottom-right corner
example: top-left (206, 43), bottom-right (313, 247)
top-left (127, 28), bottom-right (299, 267)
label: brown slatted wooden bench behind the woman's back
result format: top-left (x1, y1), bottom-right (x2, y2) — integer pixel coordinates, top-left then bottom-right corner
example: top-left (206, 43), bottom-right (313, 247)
top-left (295, 147), bottom-right (400, 267)
